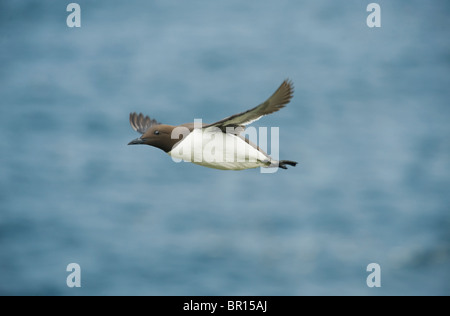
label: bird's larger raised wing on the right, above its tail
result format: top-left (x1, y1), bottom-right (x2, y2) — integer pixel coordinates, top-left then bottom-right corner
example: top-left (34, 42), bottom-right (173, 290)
top-left (203, 80), bottom-right (294, 132)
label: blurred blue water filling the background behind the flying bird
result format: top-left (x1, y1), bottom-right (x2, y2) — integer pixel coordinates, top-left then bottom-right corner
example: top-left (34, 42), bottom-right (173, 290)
top-left (0, 0), bottom-right (450, 295)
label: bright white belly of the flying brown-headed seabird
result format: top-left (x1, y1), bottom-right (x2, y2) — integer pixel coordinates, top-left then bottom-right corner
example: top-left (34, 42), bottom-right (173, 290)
top-left (168, 128), bottom-right (270, 170)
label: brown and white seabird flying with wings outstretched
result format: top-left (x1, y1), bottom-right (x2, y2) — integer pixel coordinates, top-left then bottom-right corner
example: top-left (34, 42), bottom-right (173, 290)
top-left (128, 79), bottom-right (297, 170)
